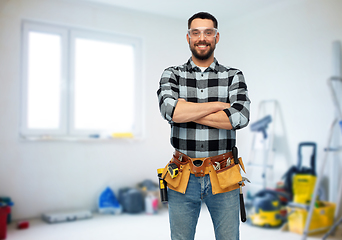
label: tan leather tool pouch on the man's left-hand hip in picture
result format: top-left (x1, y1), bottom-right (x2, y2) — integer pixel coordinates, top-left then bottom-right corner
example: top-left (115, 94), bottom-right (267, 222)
top-left (162, 158), bottom-right (190, 194)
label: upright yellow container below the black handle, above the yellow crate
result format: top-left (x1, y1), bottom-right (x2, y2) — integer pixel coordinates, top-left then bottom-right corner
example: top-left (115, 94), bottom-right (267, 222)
top-left (293, 174), bottom-right (316, 204)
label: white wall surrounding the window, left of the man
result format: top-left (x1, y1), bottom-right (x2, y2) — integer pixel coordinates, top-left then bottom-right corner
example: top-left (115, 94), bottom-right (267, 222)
top-left (0, 0), bottom-right (189, 219)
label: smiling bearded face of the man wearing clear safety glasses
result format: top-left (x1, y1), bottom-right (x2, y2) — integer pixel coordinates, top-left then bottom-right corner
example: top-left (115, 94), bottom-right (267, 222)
top-left (187, 18), bottom-right (219, 60)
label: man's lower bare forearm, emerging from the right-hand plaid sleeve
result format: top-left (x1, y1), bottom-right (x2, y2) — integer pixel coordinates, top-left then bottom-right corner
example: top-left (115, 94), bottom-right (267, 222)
top-left (194, 111), bottom-right (233, 130)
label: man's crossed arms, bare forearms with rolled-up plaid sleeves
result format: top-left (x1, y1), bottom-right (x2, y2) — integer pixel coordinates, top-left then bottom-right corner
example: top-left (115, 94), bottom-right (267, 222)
top-left (157, 68), bottom-right (250, 130)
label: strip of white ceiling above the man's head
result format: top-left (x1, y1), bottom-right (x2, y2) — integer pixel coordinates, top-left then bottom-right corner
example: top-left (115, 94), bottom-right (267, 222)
top-left (65, 0), bottom-right (289, 21)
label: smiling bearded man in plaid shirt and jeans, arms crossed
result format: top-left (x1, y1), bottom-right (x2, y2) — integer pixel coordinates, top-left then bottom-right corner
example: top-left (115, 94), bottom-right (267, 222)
top-left (157, 12), bottom-right (250, 240)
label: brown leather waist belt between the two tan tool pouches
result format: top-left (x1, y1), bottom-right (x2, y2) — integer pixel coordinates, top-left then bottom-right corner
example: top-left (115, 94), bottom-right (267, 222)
top-left (171, 150), bottom-right (234, 177)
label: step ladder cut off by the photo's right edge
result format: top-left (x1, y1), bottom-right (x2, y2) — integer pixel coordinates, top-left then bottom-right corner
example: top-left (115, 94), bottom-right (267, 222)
top-left (302, 77), bottom-right (342, 240)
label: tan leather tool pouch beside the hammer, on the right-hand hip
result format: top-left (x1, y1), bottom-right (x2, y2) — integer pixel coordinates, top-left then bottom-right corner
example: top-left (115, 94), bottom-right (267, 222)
top-left (209, 158), bottom-right (246, 194)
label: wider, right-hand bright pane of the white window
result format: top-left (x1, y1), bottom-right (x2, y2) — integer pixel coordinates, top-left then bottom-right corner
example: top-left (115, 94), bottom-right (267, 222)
top-left (74, 38), bottom-right (134, 132)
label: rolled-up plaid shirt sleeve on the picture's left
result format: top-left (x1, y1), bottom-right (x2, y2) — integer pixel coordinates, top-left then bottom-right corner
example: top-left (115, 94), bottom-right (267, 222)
top-left (157, 68), bottom-right (179, 123)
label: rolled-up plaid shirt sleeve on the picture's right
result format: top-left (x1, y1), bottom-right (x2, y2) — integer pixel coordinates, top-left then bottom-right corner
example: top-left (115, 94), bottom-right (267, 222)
top-left (224, 71), bottom-right (251, 129)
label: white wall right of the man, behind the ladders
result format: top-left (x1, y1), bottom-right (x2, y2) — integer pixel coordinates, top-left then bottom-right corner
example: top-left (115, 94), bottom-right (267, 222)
top-left (218, 0), bottom-right (342, 208)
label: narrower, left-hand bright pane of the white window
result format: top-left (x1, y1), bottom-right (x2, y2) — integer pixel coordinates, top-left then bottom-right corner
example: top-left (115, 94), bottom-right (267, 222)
top-left (27, 32), bottom-right (61, 129)
